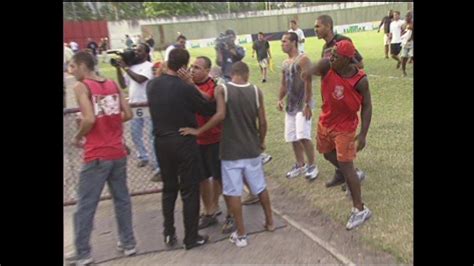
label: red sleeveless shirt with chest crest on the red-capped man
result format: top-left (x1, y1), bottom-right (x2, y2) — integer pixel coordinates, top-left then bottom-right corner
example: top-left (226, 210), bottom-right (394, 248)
top-left (319, 69), bottom-right (366, 132)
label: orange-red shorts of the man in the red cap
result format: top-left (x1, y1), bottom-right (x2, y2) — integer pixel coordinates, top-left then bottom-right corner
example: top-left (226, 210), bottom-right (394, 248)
top-left (316, 123), bottom-right (356, 162)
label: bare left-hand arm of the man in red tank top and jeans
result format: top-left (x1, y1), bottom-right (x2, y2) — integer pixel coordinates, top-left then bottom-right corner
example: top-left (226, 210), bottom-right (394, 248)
top-left (72, 82), bottom-right (95, 147)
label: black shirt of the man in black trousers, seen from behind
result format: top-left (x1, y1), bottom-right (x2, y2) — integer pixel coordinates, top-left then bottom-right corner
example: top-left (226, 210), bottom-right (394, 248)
top-left (146, 74), bottom-right (216, 137)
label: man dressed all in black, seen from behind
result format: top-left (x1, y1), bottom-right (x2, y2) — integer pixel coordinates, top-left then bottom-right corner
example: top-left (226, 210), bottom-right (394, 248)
top-left (147, 48), bottom-right (216, 249)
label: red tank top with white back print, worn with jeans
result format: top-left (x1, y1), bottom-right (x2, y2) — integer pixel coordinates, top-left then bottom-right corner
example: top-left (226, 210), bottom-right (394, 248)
top-left (83, 79), bottom-right (127, 162)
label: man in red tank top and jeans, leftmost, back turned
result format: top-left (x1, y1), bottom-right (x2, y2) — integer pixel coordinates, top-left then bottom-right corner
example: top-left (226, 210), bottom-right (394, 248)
top-left (66, 52), bottom-right (136, 265)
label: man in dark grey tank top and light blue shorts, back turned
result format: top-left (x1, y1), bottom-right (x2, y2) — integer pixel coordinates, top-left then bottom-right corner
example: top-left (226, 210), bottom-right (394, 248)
top-left (180, 62), bottom-right (275, 247)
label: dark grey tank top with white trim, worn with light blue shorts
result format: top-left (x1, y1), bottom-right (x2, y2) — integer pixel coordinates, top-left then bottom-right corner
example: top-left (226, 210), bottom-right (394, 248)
top-left (219, 82), bottom-right (262, 160)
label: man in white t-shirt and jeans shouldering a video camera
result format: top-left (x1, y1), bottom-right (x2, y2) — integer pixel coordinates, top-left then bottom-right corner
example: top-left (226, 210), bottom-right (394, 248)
top-left (115, 43), bottom-right (160, 181)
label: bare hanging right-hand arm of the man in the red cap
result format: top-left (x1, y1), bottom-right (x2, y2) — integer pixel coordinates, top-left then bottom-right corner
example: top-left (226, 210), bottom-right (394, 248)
top-left (356, 77), bottom-right (372, 151)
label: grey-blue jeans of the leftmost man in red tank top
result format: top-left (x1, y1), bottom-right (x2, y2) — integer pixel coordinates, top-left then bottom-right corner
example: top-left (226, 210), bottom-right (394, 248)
top-left (73, 158), bottom-right (136, 259)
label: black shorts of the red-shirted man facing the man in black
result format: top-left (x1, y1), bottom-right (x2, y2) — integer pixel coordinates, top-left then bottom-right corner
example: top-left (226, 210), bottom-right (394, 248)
top-left (199, 143), bottom-right (222, 182)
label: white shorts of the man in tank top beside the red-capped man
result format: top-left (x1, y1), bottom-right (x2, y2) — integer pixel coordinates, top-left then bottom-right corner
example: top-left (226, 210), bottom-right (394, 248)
top-left (285, 112), bottom-right (312, 142)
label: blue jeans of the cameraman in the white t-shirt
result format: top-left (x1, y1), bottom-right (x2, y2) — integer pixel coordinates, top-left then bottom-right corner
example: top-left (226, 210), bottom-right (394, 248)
top-left (130, 117), bottom-right (160, 168)
